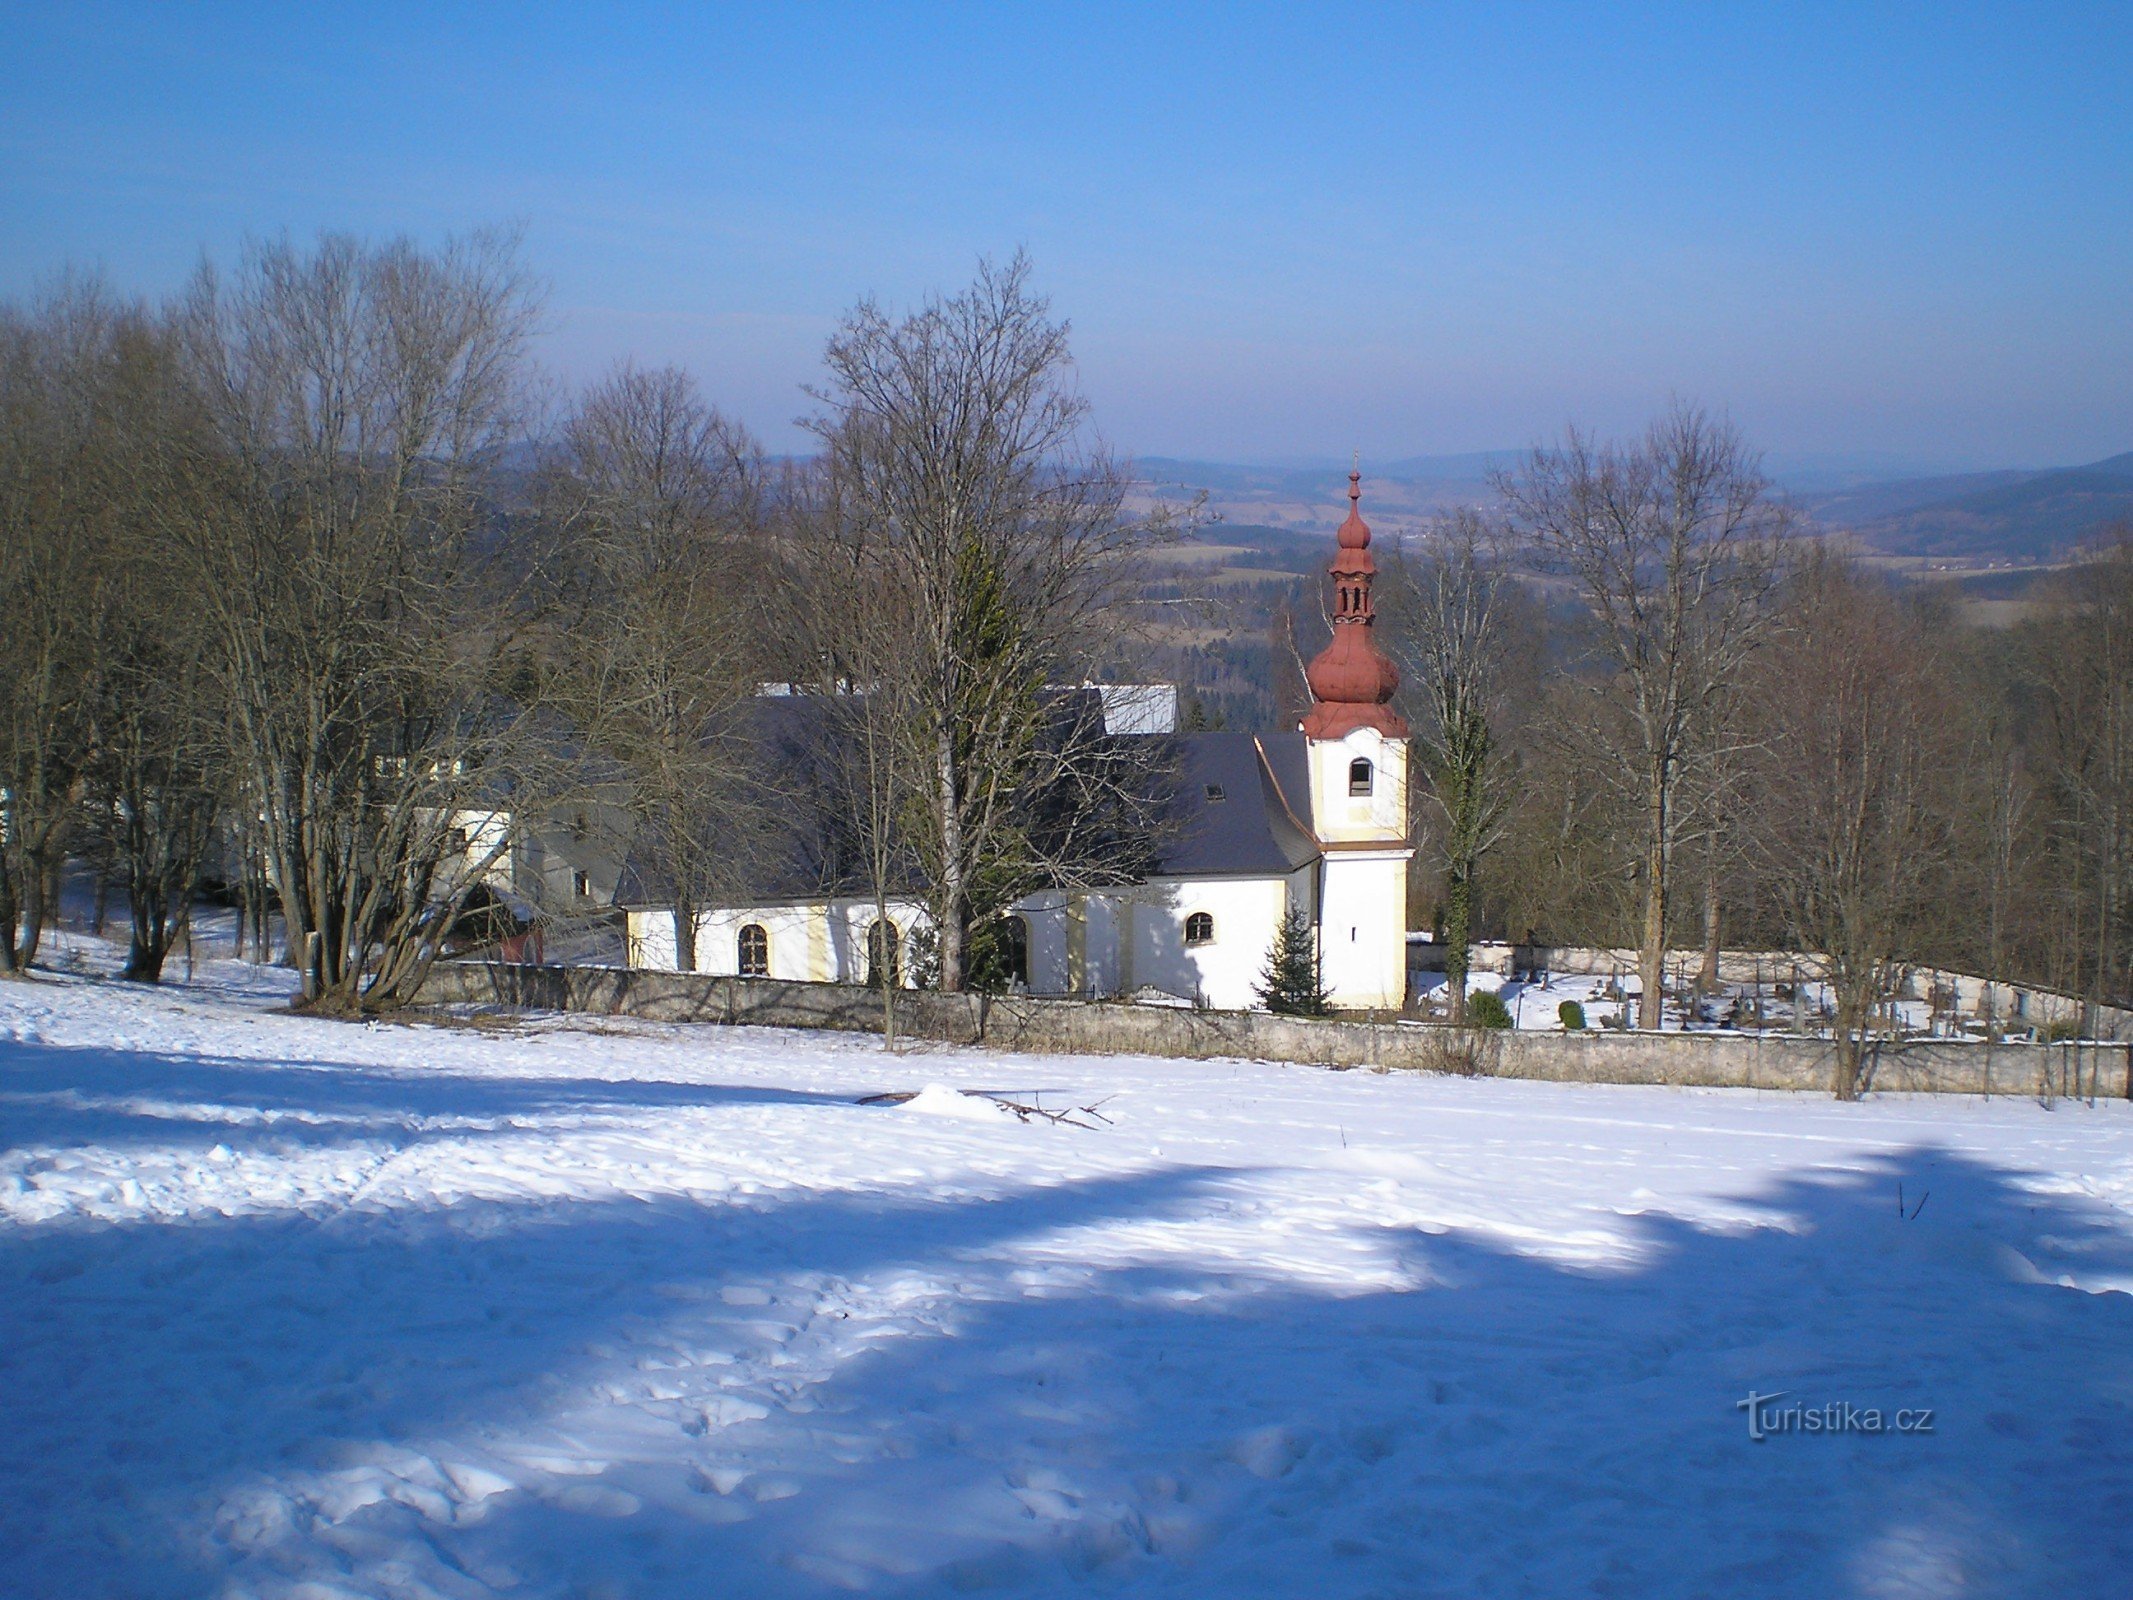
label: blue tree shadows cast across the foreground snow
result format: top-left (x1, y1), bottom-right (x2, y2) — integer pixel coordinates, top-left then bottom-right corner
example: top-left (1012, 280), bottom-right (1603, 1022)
top-left (0, 1045), bottom-right (2133, 1596)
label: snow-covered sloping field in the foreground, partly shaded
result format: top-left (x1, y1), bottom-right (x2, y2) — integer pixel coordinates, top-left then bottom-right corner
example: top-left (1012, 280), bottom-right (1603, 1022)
top-left (0, 964), bottom-right (2133, 1600)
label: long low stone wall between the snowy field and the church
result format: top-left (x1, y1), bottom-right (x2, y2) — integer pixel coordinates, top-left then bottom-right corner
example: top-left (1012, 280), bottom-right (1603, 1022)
top-left (422, 962), bottom-right (2133, 1099)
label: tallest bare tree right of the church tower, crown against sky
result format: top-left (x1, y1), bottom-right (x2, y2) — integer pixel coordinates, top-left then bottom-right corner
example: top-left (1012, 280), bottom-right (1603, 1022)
top-left (1497, 405), bottom-right (1790, 1028)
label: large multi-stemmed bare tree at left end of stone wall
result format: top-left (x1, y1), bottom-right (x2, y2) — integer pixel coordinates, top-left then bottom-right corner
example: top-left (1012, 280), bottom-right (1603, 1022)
top-left (164, 235), bottom-right (538, 1011)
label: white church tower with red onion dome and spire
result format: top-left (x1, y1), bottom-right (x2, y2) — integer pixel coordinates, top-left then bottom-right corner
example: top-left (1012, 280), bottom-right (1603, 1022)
top-left (1303, 469), bottom-right (1414, 1011)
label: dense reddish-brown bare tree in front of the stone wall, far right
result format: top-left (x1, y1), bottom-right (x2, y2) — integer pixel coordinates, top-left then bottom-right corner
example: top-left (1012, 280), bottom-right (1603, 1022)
top-left (1747, 555), bottom-right (1964, 1099)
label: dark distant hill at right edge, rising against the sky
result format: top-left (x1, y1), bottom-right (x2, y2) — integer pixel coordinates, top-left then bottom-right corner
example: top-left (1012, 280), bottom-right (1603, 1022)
top-left (1809, 452), bottom-right (2133, 561)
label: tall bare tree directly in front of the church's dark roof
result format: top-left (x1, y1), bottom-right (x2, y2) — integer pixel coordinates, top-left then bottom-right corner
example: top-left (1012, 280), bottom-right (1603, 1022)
top-left (813, 256), bottom-right (1156, 990)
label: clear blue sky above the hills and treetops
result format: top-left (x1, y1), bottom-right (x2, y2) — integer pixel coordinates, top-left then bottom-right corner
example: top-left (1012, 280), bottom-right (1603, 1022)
top-left (0, 0), bottom-right (2133, 469)
